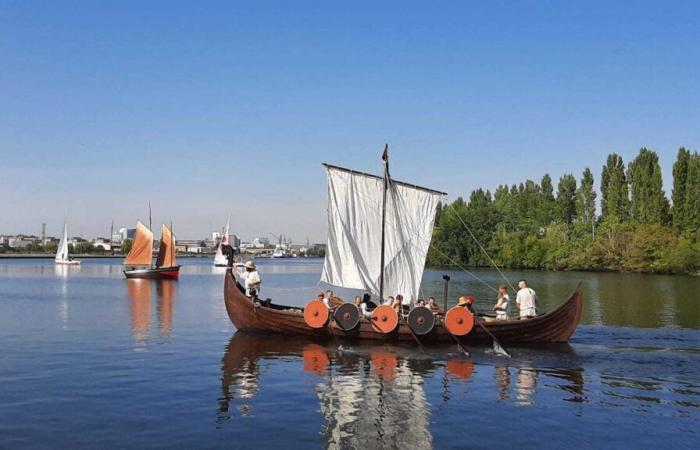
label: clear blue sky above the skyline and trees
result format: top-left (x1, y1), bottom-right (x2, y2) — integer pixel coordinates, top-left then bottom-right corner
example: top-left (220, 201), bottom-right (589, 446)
top-left (0, 1), bottom-right (700, 242)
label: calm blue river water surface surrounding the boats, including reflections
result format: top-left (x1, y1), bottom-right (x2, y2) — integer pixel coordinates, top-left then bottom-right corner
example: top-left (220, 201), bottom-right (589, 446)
top-left (0, 260), bottom-right (700, 449)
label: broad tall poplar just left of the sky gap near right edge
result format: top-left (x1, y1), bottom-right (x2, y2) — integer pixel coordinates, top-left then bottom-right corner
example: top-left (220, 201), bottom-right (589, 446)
top-left (627, 148), bottom-right (669, 224)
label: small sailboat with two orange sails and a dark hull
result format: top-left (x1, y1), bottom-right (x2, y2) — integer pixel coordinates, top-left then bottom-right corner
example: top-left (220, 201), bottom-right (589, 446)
top-left (124, 222), bottom-right (180, 279)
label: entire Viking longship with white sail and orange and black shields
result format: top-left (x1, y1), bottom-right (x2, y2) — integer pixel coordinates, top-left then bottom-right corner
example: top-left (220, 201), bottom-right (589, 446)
top-left (224, 148), bottom-right (583, 344)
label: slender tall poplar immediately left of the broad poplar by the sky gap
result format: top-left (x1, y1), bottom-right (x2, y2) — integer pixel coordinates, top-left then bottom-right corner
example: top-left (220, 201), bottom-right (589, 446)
top-left (600, 153), bottom-right (629, 222)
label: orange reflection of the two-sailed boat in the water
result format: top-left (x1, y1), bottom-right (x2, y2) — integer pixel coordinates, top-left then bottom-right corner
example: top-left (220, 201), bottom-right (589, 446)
top-left (125, 279), bottom-right (177, 341)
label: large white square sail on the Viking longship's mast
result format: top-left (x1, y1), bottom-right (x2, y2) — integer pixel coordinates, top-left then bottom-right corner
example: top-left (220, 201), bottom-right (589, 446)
top-left (321, 166), bottom-right (444, 299)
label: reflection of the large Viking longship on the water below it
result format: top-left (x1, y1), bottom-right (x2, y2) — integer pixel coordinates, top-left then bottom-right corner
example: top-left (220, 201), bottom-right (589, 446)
top-left (217, 331), bottom-right (585, 448)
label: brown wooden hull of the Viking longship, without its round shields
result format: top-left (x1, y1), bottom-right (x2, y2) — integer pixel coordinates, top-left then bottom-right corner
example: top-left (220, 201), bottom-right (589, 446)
top-left (224, 269), bottom-right (583, 344)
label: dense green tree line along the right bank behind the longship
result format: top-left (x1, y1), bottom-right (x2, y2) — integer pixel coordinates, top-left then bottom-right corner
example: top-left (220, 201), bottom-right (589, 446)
top-left (427, 147), bottom-right (700, 273)
